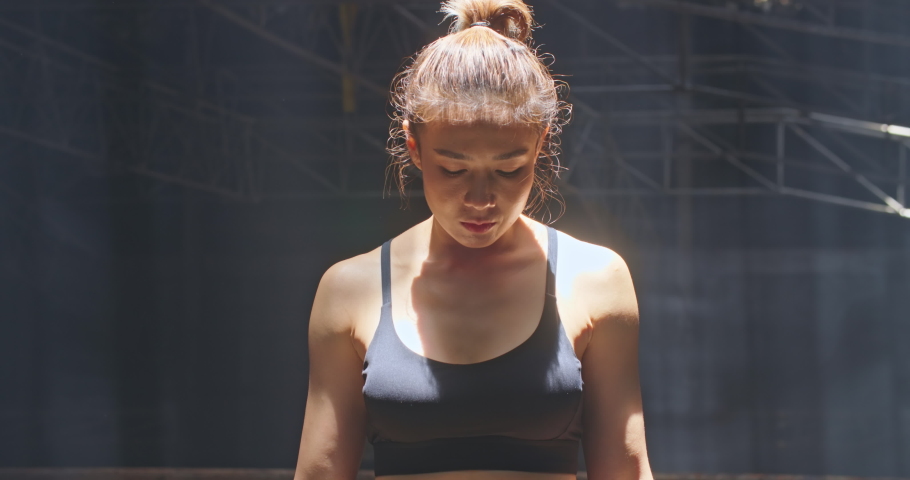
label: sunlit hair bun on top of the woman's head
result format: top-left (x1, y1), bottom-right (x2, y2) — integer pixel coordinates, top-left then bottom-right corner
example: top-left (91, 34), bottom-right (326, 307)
top-left (442, 0), bottom-right (534, 42)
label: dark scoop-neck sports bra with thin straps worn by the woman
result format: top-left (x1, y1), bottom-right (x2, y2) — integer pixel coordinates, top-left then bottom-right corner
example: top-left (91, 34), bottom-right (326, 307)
top-left (363, 227), bottom-right (582, 476)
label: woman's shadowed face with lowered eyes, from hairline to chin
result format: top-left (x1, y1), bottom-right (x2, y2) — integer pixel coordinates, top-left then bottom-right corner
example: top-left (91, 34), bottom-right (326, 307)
top-left (406, 122), bottom-right (546, 248)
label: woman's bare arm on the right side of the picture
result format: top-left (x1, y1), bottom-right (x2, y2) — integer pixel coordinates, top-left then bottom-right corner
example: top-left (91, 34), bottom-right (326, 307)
top-left (582, 250), bottom-right (653, 480)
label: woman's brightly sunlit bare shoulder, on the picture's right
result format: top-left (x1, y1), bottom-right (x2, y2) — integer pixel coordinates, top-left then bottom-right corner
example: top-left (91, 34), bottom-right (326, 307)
top-left (556, 232), bottom-right (638, 322)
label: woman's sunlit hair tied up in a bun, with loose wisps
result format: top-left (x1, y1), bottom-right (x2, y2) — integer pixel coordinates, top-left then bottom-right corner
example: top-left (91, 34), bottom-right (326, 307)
top-left (386, 0), bottom-right (571, 217)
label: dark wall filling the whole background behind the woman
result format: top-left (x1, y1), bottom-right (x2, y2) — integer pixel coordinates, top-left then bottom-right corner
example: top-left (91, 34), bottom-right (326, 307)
top-left (0, 0), bottom-right (910, 476)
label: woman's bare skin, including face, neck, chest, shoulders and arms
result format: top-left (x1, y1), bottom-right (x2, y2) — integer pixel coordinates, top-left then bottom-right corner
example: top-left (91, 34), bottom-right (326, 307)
top-left (294, 123), bottom-right (652, 480)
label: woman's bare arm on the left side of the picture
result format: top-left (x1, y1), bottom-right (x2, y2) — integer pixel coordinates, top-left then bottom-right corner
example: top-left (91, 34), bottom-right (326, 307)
top-left (294, 260), bottom-right (366, 480)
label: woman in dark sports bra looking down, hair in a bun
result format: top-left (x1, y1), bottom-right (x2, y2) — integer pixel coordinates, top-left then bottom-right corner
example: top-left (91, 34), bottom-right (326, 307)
top-left (295, 0), bottom-right (651, 480)
